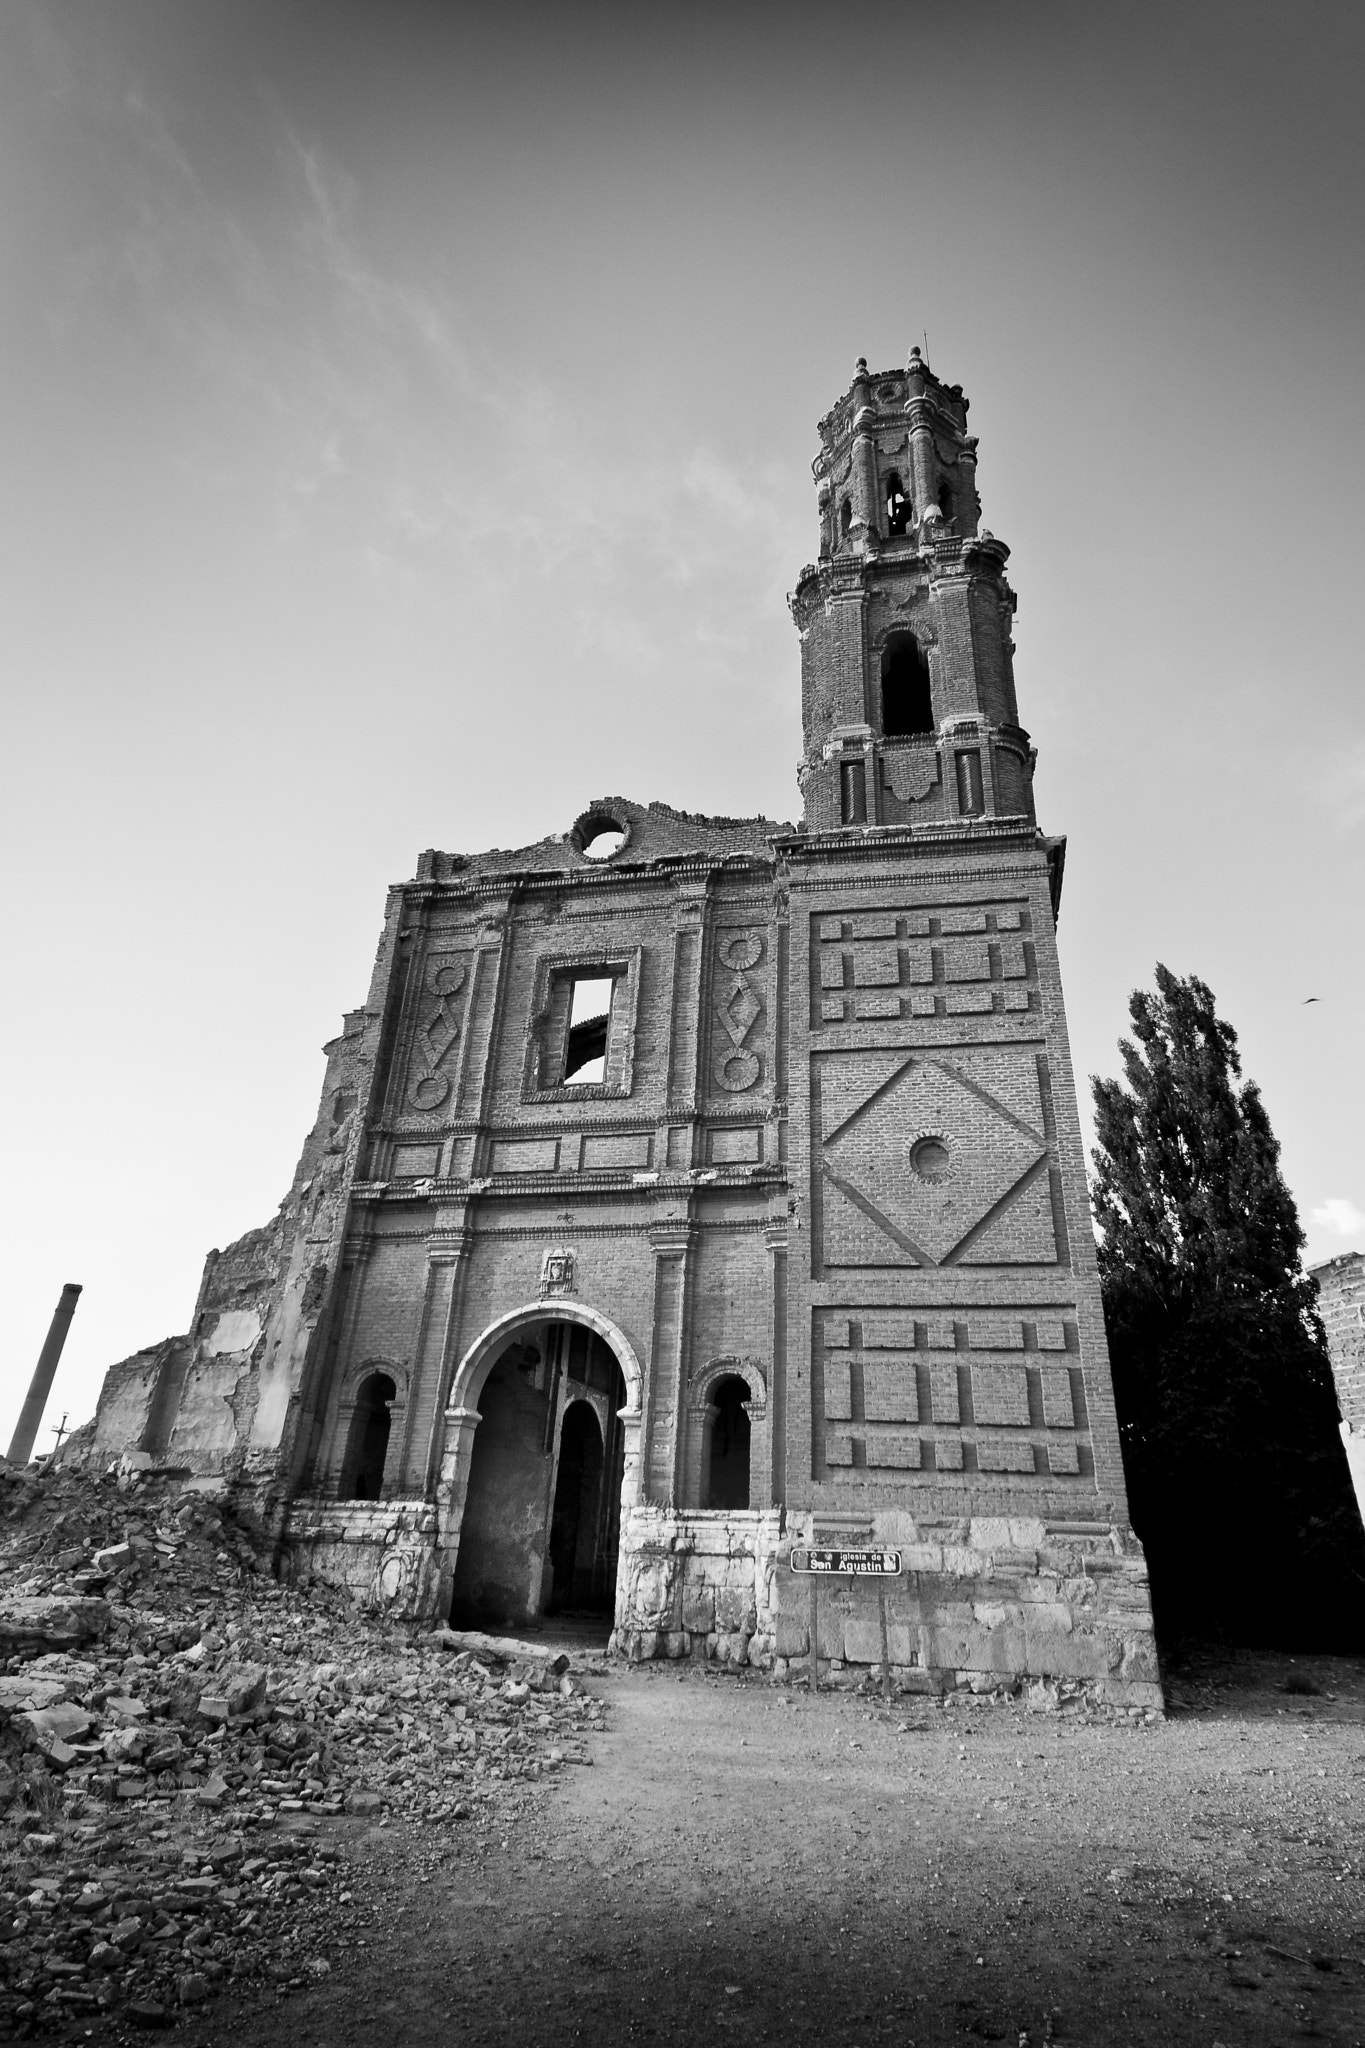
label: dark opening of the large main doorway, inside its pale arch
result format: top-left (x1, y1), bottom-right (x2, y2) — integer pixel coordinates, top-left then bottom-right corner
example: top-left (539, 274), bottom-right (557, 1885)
top-left (450, 1321), bottom-right (626, 1626)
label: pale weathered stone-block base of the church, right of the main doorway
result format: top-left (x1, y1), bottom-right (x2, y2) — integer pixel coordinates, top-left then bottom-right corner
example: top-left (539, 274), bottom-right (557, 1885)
top-left (612, 1507), bottom-right (1162, 1712)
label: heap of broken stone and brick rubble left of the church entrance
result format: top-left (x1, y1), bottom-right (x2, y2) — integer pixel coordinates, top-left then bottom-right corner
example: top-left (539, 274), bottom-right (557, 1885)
top-left (0, 1466), bottom-right (602, 2032)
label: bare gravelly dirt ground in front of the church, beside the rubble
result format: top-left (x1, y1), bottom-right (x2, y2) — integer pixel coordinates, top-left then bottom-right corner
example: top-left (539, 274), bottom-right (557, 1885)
top-left (176, 1655), bottom-right (1365, 2048)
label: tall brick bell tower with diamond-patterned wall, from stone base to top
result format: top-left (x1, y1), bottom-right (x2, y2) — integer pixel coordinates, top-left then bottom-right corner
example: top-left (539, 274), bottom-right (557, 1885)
top-left (780, 348), bottom-right (1160, 1706)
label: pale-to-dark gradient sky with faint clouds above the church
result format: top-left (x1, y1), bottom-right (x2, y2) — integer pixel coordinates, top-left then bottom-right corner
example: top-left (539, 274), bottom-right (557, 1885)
top-left (0, 0), bottom-right (1365, 1448)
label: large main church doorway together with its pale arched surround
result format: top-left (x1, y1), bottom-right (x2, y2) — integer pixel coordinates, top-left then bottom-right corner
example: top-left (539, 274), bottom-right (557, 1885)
top-left (436, 1298), bottom-right (643, 1624)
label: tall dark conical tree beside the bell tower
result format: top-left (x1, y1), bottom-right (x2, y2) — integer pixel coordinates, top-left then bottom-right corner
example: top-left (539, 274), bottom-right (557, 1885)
top-left (1091, 963), bottom-right (1365, 1649)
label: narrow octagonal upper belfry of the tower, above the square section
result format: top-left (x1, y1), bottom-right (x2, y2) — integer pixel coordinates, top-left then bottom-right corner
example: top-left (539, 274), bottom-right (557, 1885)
top-left (792, 348), bottom-right (1033, 831)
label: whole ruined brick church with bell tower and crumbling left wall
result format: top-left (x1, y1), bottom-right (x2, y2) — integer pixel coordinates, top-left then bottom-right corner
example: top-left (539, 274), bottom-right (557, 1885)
top-left (80, 350), bottom-right (1160, 1704)
